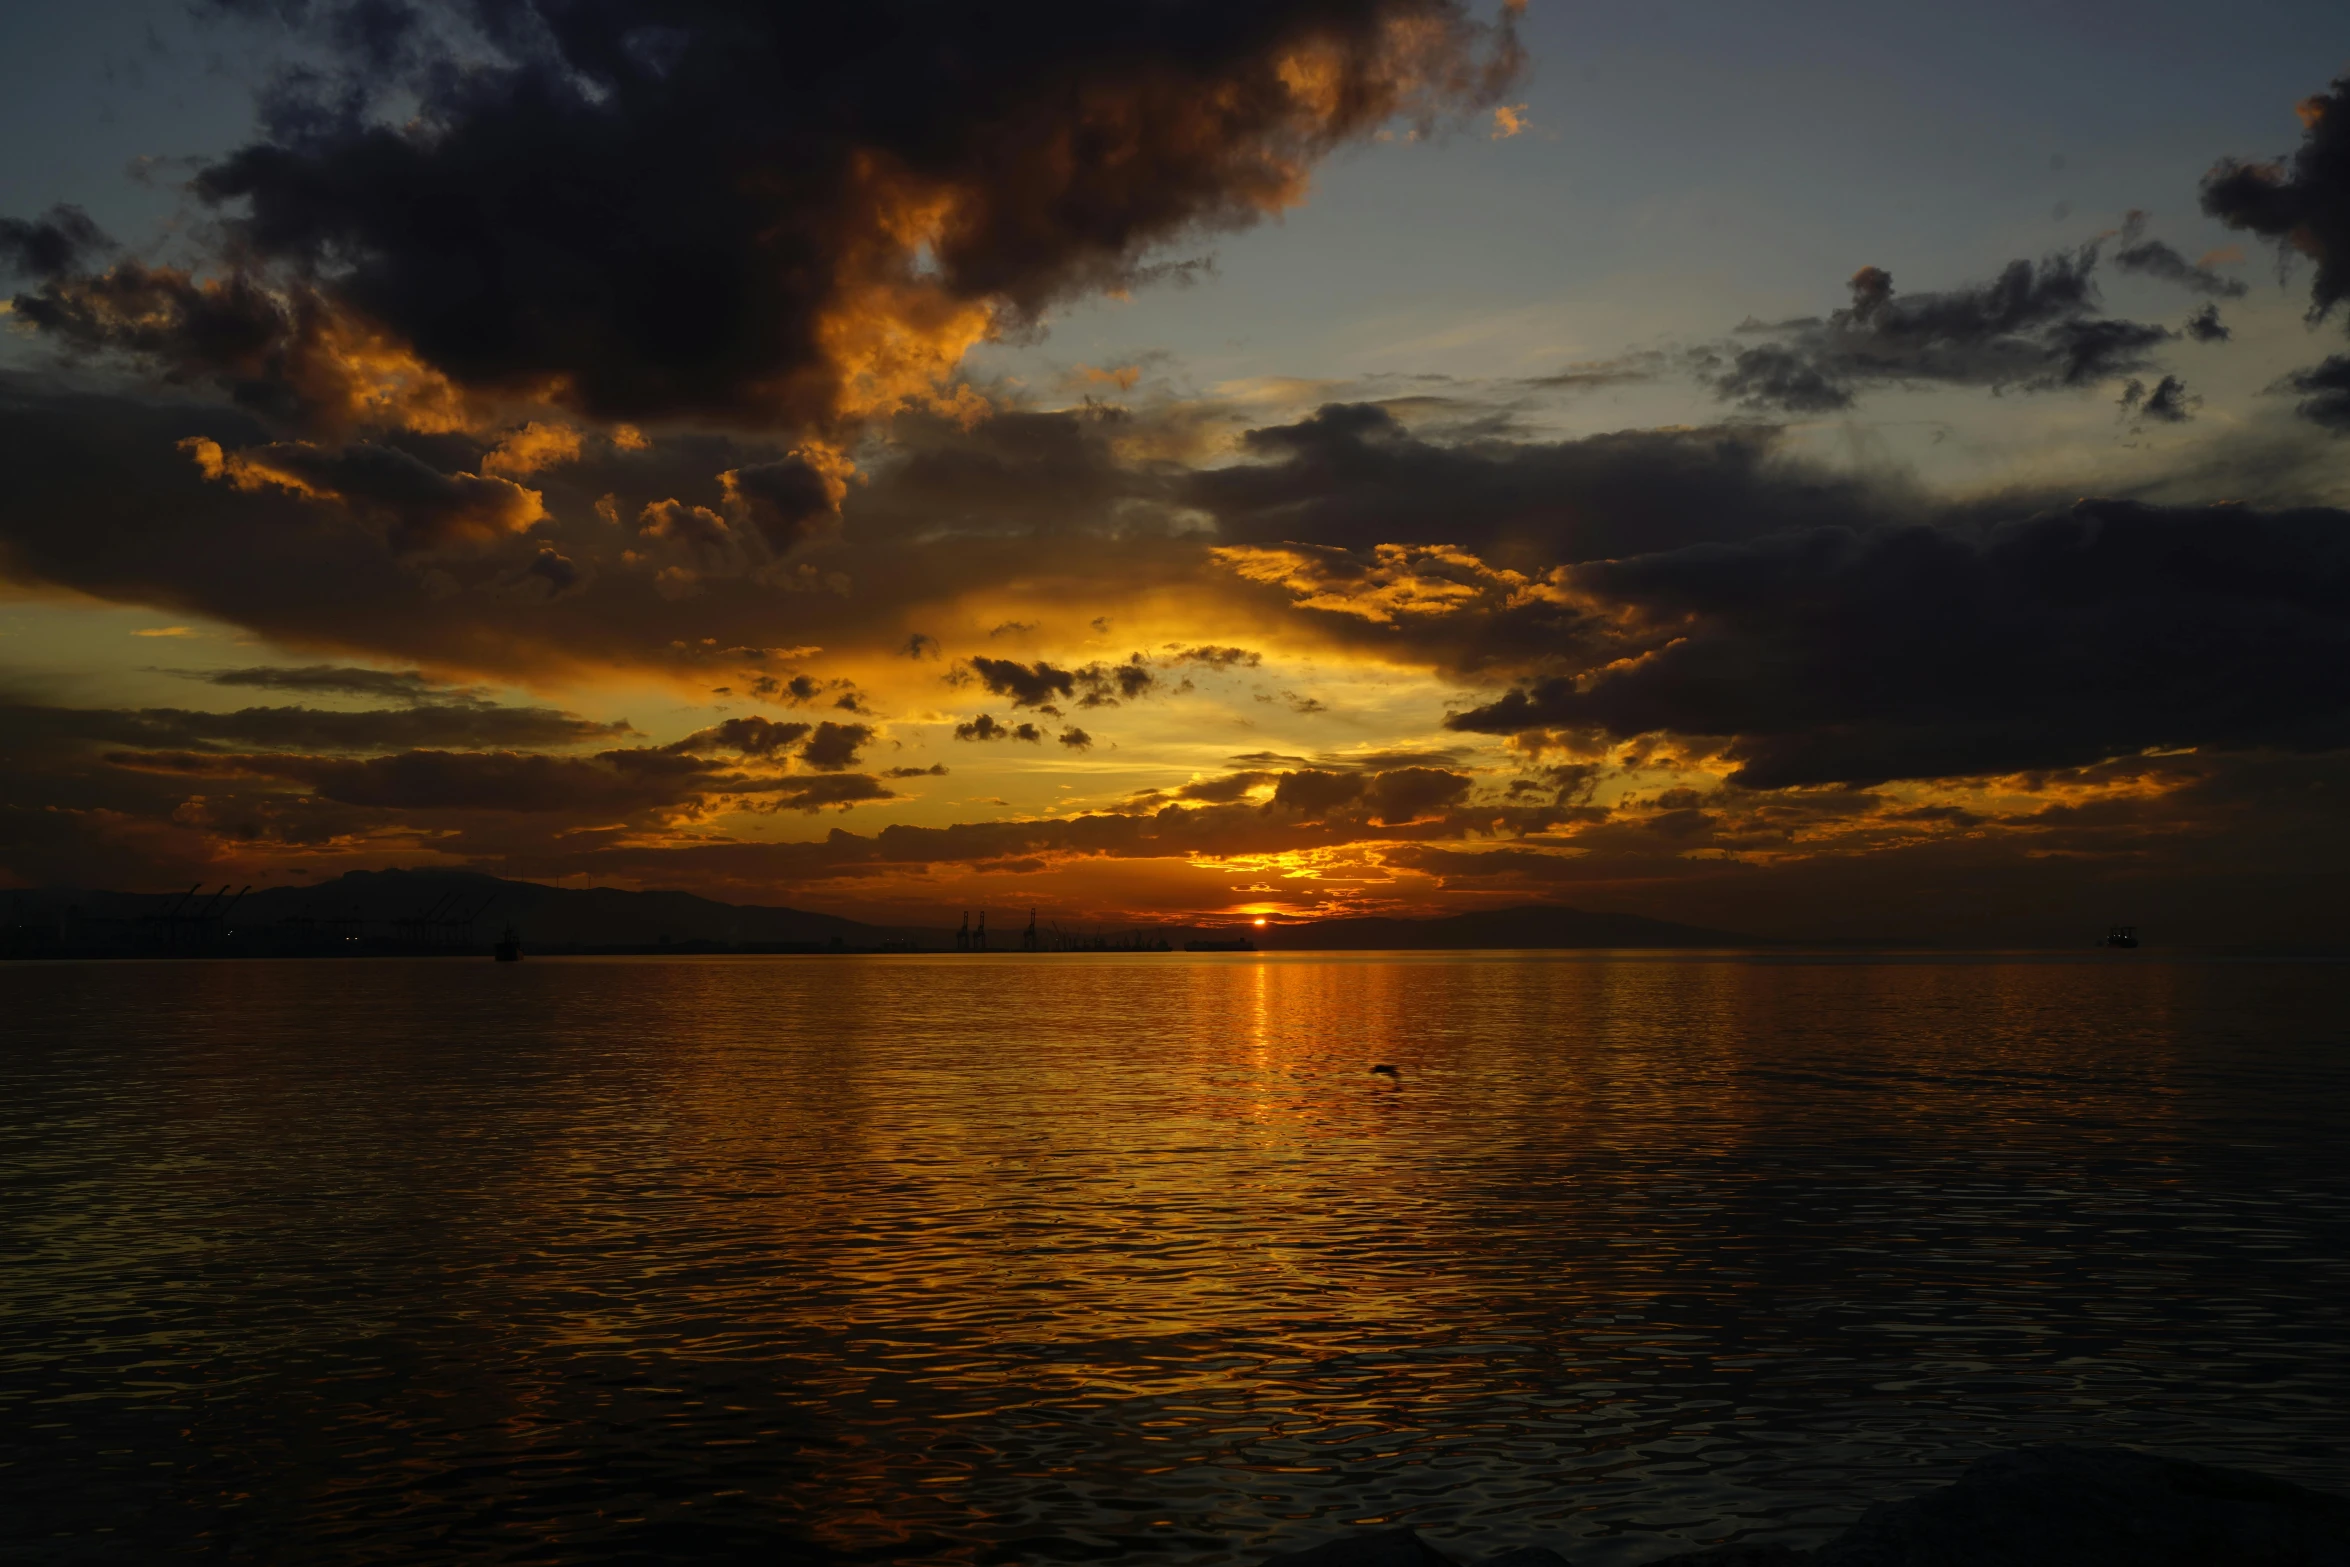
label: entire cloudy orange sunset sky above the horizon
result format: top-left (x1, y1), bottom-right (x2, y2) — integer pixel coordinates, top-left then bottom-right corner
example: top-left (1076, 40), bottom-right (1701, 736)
top-left (0, 0), bottom-right (2350, 942)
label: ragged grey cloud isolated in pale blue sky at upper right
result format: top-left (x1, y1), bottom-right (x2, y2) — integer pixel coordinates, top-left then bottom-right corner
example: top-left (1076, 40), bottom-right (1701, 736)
top-left (1706, 244), bottom-right (2171, 413)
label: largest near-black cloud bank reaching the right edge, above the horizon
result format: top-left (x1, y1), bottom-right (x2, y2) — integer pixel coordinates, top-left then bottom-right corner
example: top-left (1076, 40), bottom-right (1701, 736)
top-left (1448, 500), bottom-right (2350, 787)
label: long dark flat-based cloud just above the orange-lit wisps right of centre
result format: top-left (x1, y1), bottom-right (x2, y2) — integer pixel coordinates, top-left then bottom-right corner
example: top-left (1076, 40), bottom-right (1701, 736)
top-left (1182, 404), bottom-right (1901, 564)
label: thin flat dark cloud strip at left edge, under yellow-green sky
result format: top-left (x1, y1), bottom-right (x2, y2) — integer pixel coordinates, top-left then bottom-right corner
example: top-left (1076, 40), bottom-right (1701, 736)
top-left (0, 702), bottom-right (632, 752)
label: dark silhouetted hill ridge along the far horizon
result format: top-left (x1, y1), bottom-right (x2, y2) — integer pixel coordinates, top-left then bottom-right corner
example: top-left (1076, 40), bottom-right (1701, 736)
top-left (7, 869), bottom-right (1774, 951)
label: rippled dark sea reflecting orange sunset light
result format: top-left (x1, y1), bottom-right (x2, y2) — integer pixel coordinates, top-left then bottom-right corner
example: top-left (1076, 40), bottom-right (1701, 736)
top-left (0, 954), bottom-right (2350, 1565)
